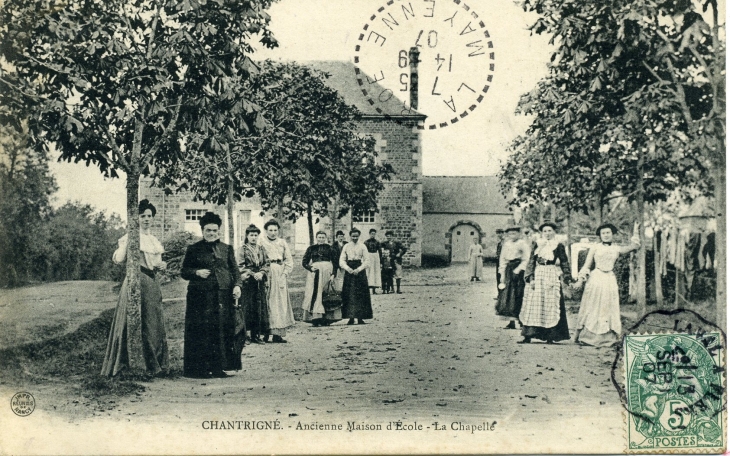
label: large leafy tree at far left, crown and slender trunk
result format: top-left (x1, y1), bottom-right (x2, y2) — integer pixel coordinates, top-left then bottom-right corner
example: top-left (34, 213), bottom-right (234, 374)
top-left (0, 0), bottom-right (276, 369)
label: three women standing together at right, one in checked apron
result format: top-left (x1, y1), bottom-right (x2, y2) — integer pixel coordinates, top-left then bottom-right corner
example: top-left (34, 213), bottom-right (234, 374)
top-left (496, 222), bottom-right (639, 346)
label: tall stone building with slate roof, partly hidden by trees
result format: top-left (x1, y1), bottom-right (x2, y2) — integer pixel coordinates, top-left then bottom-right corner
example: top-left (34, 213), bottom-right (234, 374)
top-left (140, 61), bottom-right (426, 266)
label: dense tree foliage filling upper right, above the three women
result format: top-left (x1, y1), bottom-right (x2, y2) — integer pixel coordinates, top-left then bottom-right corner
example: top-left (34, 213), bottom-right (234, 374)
top-left (502, 0), bottom-right (724, 211)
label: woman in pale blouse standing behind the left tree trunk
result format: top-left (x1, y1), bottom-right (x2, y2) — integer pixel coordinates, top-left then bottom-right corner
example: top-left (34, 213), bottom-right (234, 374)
top-left (101, 199), bottom-right (168, 377)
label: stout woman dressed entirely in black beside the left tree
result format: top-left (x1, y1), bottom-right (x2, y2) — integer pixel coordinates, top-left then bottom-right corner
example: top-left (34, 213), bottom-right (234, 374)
top-left (180, 212), bottom-right (246, 378)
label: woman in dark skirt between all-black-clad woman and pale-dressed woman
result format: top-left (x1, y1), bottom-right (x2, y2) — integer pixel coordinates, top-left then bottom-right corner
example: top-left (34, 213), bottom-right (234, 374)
top-left (237, 225), bottom-right (269, 344)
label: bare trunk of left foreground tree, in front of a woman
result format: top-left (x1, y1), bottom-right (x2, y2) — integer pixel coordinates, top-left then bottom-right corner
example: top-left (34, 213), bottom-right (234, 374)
top-left (127, 171), bottom-right (147, 372)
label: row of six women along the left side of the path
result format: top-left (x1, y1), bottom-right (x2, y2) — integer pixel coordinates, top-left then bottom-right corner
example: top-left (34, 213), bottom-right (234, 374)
top-left (101, 200), bottom-right (373, 378)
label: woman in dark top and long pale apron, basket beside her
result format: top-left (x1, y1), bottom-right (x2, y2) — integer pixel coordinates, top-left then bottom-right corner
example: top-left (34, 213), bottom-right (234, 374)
top-left (302, 231), bottom-right (342, 326)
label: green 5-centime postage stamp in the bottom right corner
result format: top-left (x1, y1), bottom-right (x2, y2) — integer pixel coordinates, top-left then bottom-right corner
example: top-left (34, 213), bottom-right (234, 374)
top-left (623, 332), bottom-right (726, 453)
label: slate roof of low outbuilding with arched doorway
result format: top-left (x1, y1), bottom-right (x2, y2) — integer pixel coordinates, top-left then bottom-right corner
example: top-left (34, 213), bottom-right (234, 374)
top-left (423, 176), bottom-right (512, 215)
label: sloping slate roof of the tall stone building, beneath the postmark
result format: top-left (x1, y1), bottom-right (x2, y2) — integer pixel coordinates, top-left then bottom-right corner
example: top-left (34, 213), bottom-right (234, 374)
top-left (299, 60), bottom-right (426, 119)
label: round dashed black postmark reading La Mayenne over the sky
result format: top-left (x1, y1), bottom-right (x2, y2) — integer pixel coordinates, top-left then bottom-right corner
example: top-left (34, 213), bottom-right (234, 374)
top-left (354, 0), bottom-right (495, 130)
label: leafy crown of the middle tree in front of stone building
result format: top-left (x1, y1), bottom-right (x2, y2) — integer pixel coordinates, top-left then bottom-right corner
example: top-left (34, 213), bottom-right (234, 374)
top-left (157, 61), bottom-right (393, 244)
